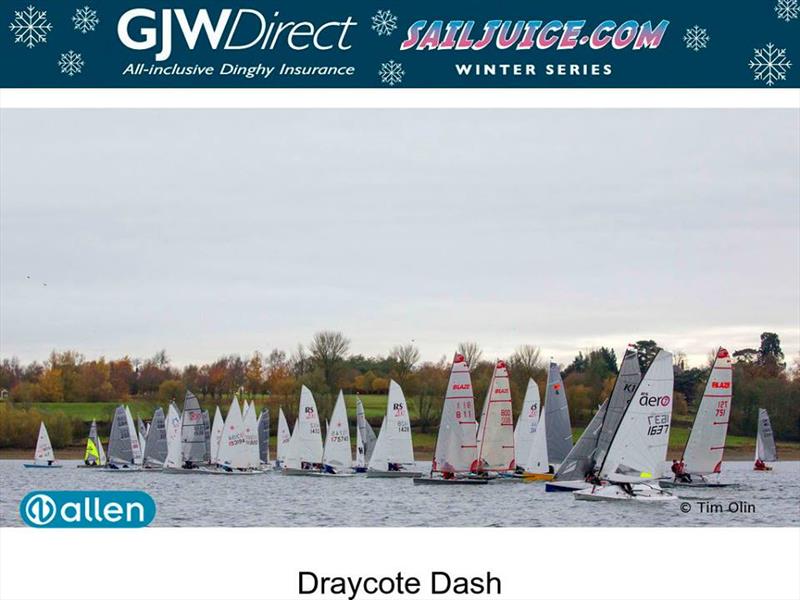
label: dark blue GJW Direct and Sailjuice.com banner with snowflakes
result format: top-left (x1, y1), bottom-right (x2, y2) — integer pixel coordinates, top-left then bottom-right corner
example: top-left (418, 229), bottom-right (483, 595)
top-left (0, 0), bottom-right (800, 88)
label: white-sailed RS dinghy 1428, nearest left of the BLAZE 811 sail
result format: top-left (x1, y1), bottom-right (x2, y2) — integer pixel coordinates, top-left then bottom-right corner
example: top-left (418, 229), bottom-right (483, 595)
top-left (367, 380), bottom-right (422, 477)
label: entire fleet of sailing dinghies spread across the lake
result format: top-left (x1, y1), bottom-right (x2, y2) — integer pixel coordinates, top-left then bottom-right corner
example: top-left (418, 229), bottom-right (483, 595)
top-left (24, 347), bottom-right (777, 502)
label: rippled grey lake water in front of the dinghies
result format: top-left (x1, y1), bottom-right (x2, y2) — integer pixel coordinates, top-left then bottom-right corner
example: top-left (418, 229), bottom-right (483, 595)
top-left (0, 460), bottom-right (800, 527)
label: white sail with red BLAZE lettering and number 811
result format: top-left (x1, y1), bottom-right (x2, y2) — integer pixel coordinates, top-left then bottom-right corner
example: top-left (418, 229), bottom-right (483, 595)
top-left (432, 354), bottom-right (478, 473)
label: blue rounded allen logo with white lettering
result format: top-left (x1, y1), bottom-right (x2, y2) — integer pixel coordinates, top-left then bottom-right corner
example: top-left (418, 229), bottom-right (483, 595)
top-left (19, 491), bottom-right (156, 528)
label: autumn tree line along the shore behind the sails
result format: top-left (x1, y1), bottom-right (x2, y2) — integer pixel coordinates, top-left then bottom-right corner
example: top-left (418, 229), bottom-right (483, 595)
top-left (0, 331), bottom-right (800, 445)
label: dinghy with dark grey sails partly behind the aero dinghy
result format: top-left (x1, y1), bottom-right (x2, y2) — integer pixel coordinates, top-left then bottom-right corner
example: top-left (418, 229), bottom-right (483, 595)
top-left (545, 347), bottom-right (642, 492)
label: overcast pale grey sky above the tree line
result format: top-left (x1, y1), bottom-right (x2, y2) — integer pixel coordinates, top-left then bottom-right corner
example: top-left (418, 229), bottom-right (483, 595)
top-left (0, 110), bottom-right (800, 365)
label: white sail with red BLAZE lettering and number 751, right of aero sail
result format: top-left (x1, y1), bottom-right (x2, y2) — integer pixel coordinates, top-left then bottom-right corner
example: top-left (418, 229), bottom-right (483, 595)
top-left (683, 348), bottom-right (733, 475)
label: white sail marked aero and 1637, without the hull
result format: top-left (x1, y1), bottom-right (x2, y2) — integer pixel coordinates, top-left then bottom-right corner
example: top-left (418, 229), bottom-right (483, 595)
top-left (600, 350), bottom-right (673, 483)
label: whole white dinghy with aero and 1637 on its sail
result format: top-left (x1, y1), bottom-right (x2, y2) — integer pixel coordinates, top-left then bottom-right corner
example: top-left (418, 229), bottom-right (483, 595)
top-left (573, 350), bottom-right (677, 502)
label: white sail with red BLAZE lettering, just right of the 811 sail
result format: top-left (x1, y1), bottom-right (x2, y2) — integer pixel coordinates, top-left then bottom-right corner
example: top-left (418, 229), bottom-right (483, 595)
top-left (477, 360), bottom-right (515, 471)
